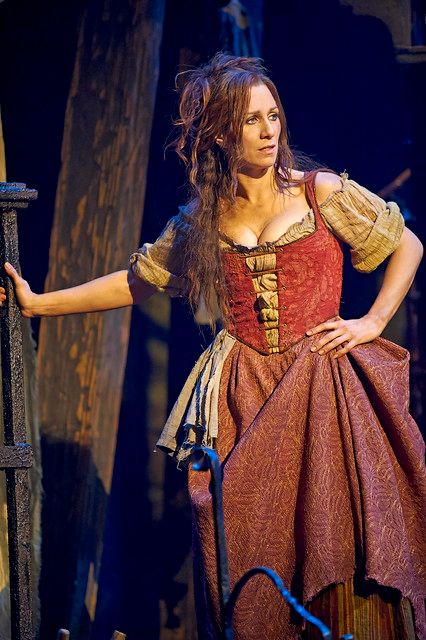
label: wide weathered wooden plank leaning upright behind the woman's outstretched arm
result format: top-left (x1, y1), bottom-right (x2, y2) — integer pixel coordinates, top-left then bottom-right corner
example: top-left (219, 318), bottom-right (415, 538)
top-left (38, 0), bottom-right (164, 640)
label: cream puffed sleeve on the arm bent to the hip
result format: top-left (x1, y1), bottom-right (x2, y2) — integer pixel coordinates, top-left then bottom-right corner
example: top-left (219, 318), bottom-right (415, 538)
top-left (319, 174), bottom-right (404, 272)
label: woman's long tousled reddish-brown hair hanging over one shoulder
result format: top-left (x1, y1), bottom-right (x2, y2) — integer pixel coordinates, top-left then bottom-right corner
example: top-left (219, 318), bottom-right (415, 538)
top-left (170, 53), bottom-right (314, 329)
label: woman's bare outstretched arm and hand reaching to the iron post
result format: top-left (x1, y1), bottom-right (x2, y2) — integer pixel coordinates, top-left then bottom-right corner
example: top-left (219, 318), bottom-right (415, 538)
top-left (0, 262), bottom-right (155, 318)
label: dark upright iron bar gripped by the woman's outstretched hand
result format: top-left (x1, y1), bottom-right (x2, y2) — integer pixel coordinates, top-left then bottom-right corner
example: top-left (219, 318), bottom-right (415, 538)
top-left (0, 182), bottom-right (37, 640)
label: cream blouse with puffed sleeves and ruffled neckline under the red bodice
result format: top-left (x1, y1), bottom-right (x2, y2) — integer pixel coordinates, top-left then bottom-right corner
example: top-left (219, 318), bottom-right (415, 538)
top-left (130, 174), bottom-right (404, 296)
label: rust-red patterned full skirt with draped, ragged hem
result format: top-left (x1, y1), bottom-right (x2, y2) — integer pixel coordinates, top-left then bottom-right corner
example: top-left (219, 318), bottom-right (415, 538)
top-left (189, 338), bottom-right (426, 640)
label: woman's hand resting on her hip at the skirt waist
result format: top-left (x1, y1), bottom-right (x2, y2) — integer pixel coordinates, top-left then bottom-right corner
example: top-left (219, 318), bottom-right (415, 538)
top-left (306, 315), bottom-right (384, 358)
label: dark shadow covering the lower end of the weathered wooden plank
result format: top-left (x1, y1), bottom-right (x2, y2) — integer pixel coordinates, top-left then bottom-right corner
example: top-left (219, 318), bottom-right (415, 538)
top-left (40, 437), bottom-right (108, 638)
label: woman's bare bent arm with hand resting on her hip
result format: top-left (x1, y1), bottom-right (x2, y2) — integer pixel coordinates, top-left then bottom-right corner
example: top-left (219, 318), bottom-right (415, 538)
top-left (306, 228), bottom-right (423, 358)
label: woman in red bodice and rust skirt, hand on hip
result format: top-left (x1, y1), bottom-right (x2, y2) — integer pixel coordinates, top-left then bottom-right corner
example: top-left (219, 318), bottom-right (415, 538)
top-left (0, 54), bottom-right (426, 640)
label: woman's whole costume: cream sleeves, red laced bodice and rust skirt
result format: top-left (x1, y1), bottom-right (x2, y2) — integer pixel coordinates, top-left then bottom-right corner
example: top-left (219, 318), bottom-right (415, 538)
top-left (131, 174), bottom-right (426, 640)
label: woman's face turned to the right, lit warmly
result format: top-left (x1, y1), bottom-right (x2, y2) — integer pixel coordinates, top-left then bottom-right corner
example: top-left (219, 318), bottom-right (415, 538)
top-left (238, 84), bottom-right (281, 176)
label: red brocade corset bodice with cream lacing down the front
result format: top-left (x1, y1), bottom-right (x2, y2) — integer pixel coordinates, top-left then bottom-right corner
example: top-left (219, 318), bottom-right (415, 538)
top-left (222, 178), bottom-right (343, 354)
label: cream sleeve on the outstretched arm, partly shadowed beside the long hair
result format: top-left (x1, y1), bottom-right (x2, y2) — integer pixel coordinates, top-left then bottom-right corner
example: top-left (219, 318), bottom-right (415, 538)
top-left (129, 211), bottom-right (189, 297)
